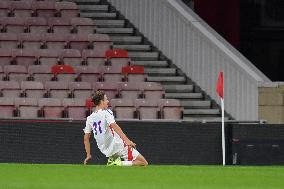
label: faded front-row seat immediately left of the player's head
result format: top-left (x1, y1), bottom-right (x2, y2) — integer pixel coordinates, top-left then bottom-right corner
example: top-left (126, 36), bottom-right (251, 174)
top-left (62, 98), bottom-right (87, 119)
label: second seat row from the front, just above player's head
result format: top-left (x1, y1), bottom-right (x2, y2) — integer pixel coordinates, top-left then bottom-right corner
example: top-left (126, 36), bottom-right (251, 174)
top-left (0, 81), bottom-right (165, 100)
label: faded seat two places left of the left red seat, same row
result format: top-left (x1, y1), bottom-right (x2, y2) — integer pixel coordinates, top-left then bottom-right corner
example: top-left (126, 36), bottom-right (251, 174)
top-left (4, 65), bottom-right (29, 81)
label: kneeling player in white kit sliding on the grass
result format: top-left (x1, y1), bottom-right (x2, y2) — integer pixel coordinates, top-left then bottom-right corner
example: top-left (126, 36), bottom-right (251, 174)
top-left (84, 91), bottom-right (148, 166)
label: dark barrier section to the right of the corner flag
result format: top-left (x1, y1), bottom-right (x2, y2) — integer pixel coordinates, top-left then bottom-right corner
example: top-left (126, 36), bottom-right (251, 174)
top-left (232, 125), bottom-right (284, 165)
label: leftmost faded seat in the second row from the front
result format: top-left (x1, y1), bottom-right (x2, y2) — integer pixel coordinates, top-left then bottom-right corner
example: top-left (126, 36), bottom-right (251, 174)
top-left (0, 81), bottom-right (21, 98)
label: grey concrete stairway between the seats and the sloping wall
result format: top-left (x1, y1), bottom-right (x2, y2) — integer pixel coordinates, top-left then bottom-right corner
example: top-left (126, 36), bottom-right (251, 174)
top-left (73, 0), bottom-right (228, 121)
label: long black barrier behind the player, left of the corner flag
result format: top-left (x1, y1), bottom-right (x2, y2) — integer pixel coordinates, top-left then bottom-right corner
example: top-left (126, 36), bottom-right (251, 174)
top-left (0, 121), bottom-right (222, 164)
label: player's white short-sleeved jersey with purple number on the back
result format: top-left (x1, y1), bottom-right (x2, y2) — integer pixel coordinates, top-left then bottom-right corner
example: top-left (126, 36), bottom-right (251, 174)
top-left (84, 109), bottom-right (124, 157)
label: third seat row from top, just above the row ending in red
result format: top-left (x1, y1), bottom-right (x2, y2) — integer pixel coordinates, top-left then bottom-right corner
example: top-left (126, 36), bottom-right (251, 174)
top-left (0, 33), bottom-right (113, 52)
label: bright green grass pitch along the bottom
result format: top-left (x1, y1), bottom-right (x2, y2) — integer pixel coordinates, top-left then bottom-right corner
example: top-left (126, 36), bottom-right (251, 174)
top-left (0, 164), bottom-right (284, 189)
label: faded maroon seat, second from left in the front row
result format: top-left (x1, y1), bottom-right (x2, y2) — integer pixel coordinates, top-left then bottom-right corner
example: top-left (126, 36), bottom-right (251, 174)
top-left (15, 98), bottom-right (39, 118)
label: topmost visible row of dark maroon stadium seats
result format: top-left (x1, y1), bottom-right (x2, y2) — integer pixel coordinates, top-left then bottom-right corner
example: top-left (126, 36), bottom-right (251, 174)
top-left (0, 0), bottom-right (79, 17)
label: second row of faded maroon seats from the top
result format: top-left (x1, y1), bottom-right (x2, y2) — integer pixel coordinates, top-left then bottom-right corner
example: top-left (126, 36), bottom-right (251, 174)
top-left (0, 17), bottom-right (96, 34)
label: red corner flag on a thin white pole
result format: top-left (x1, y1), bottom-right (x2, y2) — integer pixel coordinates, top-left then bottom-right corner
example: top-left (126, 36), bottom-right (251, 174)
top-left (216, 71), bottom-right (226, 166)
